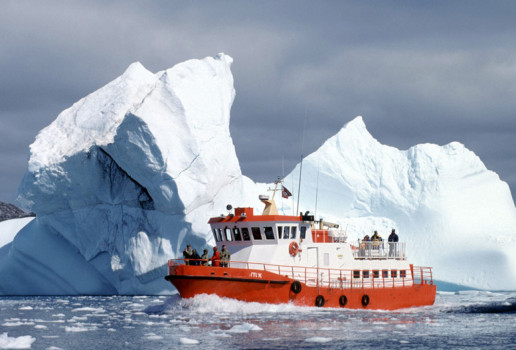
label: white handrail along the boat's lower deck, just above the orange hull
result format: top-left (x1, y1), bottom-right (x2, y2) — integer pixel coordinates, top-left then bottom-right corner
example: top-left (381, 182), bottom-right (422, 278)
top-left (168, 259), bottom-right (433, 289)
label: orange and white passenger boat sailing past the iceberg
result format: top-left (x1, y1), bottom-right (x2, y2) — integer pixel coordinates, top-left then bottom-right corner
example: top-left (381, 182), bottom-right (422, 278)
top-left (165, 182), bottom-right (436, 310)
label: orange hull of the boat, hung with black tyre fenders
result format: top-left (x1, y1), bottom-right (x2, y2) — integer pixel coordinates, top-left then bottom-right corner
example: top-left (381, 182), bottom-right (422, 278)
top-left (165, 265), bottom-right (436, 310)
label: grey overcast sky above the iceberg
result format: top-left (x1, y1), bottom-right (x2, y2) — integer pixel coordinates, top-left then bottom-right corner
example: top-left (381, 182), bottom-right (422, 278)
top-left (0, 0), bottom-right (516, 204)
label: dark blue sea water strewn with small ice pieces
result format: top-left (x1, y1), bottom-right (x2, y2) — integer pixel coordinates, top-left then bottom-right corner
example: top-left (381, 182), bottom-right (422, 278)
top-left (0, 291), bottom-right (516, 350)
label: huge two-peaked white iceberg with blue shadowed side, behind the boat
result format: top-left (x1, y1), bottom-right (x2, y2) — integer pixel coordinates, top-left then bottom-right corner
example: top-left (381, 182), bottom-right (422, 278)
top-left (0, 54), bottom-right (516, 295)
